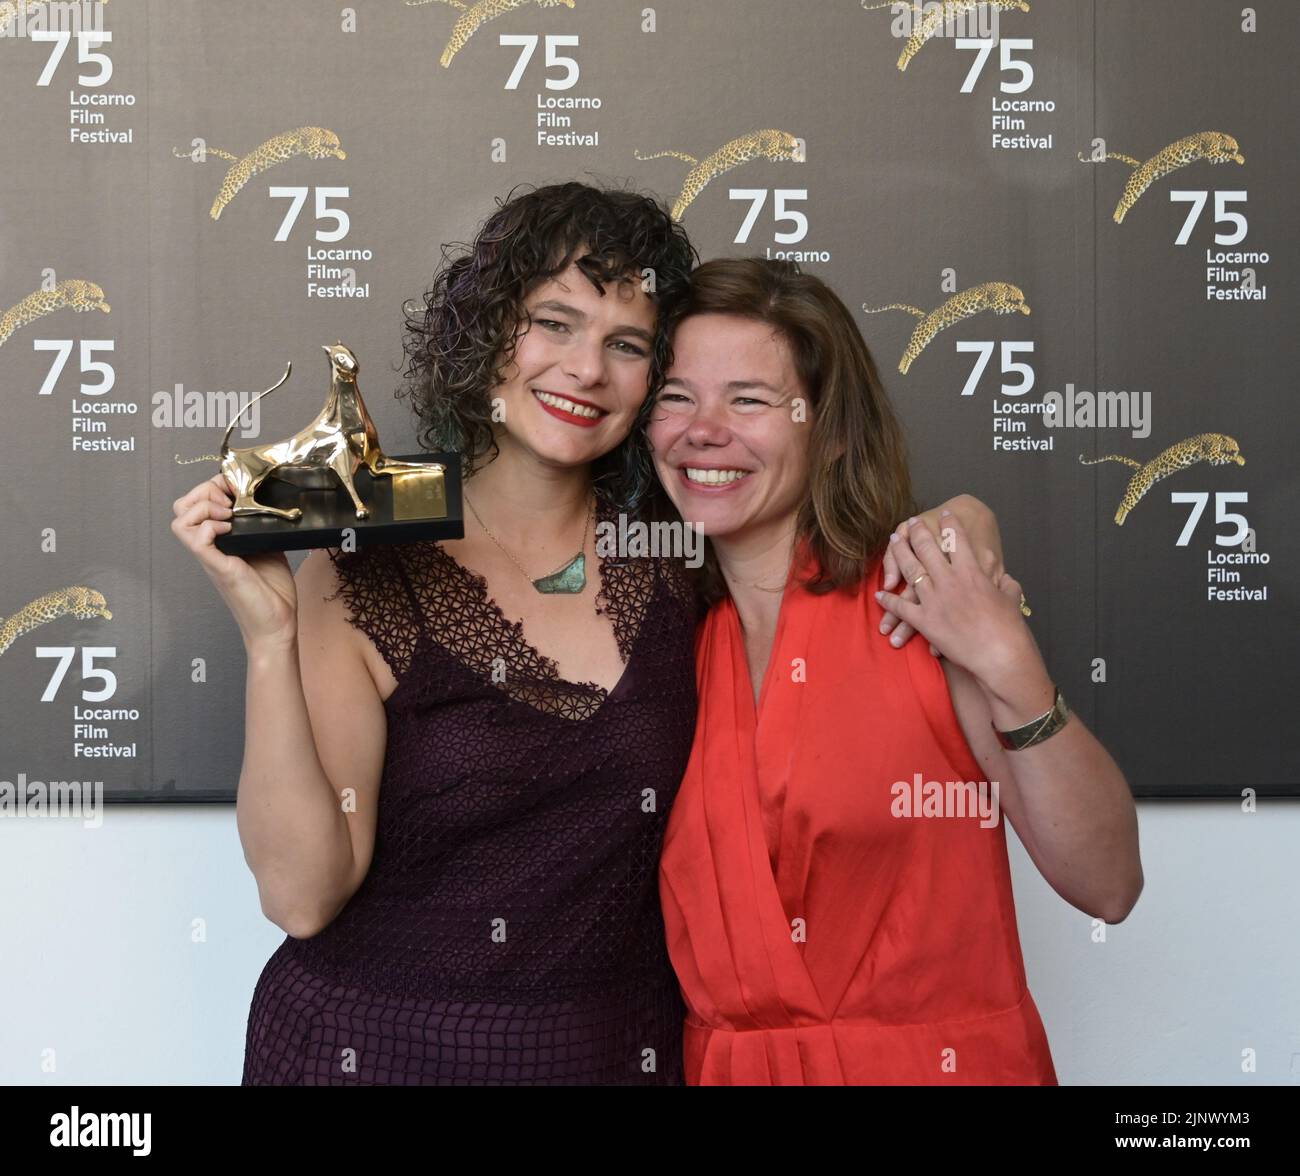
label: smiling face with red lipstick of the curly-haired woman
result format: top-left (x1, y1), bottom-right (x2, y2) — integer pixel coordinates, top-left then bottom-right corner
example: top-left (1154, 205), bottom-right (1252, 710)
top-left (490, 264), bottom-right (657, 467)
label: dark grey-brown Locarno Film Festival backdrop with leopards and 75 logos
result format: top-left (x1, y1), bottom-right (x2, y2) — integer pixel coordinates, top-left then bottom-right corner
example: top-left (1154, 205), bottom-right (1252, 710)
top-left (0, 0), bottom-right (1300, 802)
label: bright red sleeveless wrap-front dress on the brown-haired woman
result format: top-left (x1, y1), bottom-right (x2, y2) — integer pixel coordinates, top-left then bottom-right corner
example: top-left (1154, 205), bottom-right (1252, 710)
top-left (659, 550), bottom-right (1057, 1085)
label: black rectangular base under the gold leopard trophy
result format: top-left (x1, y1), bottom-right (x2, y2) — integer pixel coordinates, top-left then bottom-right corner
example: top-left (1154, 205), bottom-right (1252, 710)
top-left (216, 454), bottom-right (465, 555)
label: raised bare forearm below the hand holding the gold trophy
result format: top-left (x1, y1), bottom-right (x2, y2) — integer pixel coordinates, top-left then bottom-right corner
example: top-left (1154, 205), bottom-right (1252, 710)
top-left (235, 643), bottom-right (354, 937)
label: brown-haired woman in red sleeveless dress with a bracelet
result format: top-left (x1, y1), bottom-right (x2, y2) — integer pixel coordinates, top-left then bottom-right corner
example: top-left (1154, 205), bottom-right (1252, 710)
top-left (649, 259), bottom-right (1141, 1085)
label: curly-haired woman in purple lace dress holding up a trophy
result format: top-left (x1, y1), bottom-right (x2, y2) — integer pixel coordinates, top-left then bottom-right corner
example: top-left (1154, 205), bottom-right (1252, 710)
top-left (173, 183), bottom-right (987, 1085)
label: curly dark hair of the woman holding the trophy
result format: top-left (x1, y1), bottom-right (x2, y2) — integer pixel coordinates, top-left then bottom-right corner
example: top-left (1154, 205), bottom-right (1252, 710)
top-left (398, 181), bottom-right (699, 511)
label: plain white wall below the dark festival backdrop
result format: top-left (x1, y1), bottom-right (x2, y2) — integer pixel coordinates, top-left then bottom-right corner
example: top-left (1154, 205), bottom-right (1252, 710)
top-left (0, 800), bottom-right (1300, 1085)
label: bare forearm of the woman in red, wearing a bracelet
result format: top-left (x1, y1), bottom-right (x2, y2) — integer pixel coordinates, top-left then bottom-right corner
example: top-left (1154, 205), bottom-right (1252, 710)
top-left (980, 664), bottom-right (1143, 923)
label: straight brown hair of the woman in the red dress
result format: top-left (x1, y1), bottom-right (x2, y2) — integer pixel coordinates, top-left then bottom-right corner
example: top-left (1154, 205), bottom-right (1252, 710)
top-left (664, 257), bottom-right (918, 604)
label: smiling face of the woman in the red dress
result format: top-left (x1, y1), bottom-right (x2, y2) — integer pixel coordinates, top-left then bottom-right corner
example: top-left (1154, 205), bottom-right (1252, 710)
top-left (646, 314), bottom-right (813, 542)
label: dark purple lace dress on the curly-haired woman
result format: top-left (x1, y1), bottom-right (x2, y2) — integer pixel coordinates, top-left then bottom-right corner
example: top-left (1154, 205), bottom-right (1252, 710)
top-left (243, 496), bottom-right (696, 1085)
